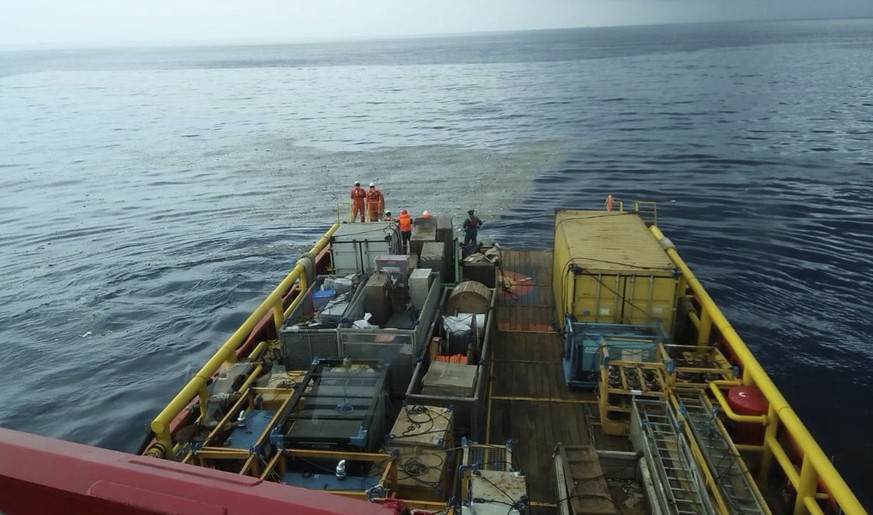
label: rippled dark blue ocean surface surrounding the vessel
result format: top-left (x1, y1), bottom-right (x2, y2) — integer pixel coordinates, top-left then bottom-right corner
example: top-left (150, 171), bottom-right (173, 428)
top-left (0, 20), bottom-right (873, 506)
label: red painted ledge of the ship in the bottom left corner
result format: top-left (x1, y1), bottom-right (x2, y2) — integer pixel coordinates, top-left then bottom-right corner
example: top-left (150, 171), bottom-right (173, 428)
top-left (0, 429), bottom-right (398, 515)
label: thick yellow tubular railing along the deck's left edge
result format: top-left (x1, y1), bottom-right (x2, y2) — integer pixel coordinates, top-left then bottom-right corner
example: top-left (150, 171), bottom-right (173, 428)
top-left (150, 224), bottom-right (339, 456)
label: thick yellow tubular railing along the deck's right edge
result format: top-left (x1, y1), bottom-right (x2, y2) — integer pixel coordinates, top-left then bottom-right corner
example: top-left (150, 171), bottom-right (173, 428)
top-left (651, 226), bottom-right (867, 515)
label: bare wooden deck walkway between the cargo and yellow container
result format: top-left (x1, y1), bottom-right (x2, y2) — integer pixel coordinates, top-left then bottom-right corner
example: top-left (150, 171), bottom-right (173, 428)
top-left (487, 250), bottom-right (596, 515)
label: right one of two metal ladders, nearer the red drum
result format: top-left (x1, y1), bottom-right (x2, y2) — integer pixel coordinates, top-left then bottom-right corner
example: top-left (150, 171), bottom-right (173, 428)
top-left (676, 390), bottom-right (770, 514)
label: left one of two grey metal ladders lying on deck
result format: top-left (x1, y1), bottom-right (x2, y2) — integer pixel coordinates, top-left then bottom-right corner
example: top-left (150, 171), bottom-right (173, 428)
top-left (630, 399), bottom-right (715, 515)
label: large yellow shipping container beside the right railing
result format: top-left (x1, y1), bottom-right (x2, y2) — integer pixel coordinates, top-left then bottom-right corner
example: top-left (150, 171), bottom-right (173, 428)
top-left (552, 210), bottom-right (679, 334)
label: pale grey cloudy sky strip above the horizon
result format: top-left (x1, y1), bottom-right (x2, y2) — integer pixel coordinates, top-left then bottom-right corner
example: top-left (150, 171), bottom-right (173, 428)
top-left (0, 0), bottom-right (873, 48)
